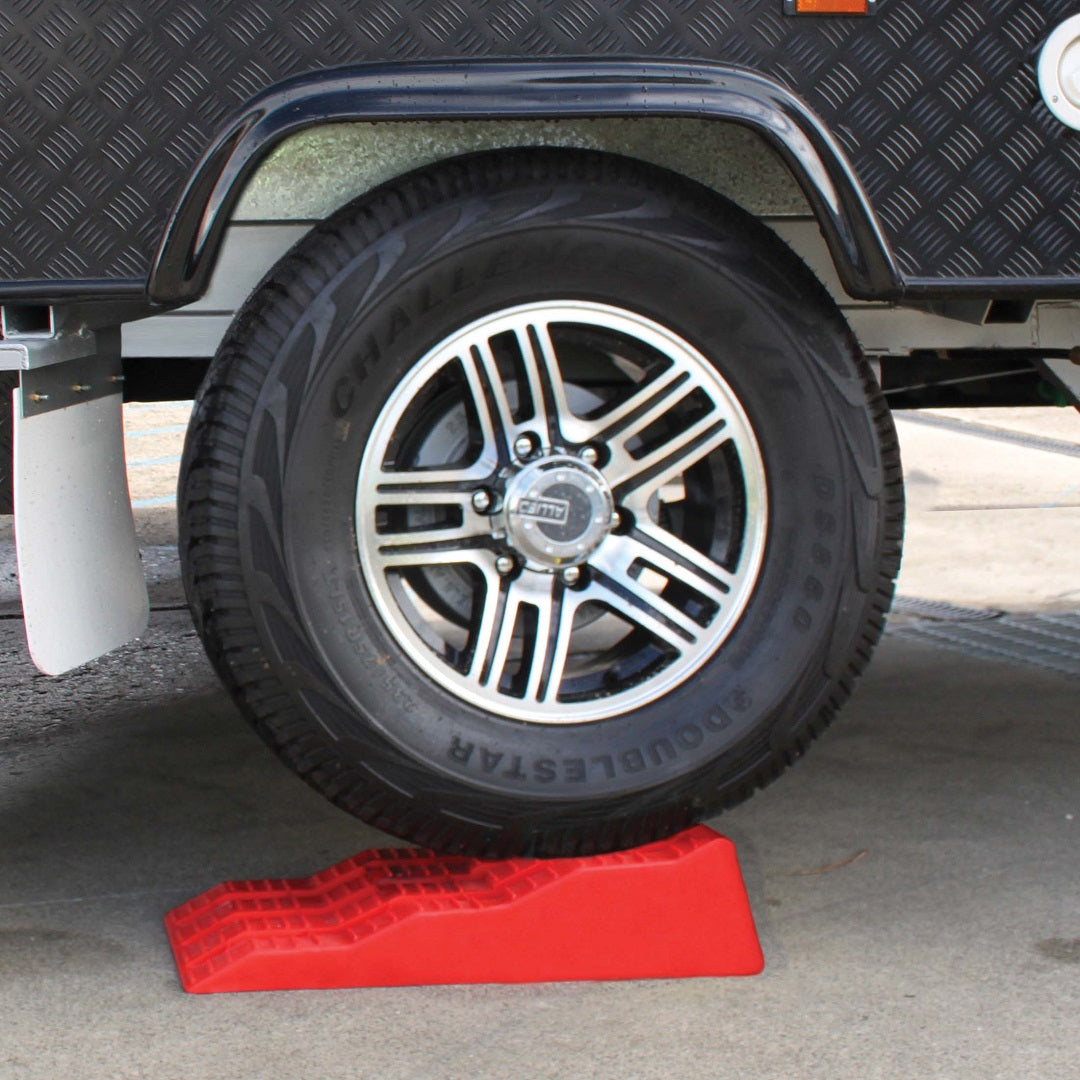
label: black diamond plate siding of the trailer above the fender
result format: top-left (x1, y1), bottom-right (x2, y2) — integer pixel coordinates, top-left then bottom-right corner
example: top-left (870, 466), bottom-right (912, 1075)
top-left (0, 0), bottom-right (1080, 282)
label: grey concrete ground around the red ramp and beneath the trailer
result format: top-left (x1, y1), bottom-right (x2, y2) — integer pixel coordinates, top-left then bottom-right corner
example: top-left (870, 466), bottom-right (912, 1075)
top-left (0, 406), bottom-right (1080, 1080)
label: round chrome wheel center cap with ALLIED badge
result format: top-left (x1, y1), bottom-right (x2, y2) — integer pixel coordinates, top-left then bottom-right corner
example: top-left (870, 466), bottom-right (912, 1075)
top-left (503, 456), bottom-right (615, 570)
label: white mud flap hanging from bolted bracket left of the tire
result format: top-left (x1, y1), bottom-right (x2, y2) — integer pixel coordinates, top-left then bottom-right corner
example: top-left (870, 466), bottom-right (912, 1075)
top-left (8, 330), bottom-right (149, 675)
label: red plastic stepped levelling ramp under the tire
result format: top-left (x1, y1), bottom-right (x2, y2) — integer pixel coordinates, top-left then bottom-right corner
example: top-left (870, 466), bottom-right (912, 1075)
top-left (165, 825), bottom-right (764, 994)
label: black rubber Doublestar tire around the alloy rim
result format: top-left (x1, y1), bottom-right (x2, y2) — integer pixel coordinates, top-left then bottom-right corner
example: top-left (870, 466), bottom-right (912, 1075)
top-left (179, 150), bottom-right (903, 856)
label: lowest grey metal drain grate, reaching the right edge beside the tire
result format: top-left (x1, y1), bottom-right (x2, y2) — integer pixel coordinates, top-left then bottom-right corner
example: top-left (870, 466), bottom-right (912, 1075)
top-left (893, 608), bottom-right (1080, 678)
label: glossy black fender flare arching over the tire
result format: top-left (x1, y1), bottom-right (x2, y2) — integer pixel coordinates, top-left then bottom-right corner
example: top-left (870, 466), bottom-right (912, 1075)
top-left (149, 59), bottom-right (902, 307)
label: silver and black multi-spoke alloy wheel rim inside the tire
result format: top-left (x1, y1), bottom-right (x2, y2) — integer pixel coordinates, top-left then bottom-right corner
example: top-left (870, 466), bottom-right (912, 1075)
top-left (355, 300), bottom-right (768, 724)
